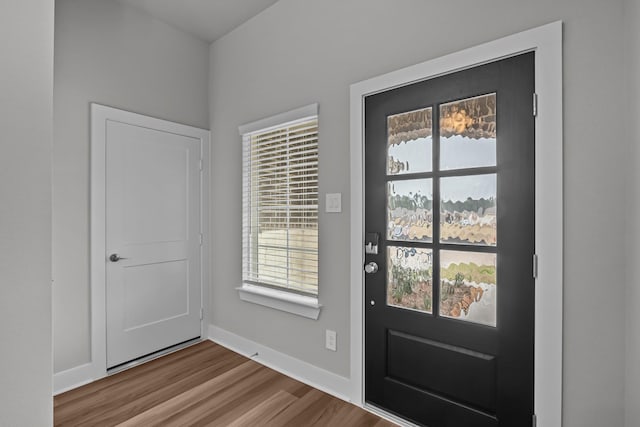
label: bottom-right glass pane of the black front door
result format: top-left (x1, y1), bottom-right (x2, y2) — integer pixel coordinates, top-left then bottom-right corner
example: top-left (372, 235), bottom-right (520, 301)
top-left (440, 251), bottom-right (497, 326)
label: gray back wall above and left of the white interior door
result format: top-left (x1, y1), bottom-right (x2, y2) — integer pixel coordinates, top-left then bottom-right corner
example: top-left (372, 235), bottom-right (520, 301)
top-left (53, 0), bottom-right (209, 372)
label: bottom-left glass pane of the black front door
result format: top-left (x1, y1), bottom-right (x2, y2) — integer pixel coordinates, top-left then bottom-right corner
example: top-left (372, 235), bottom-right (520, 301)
top-left (387, 246), bottom-right (433, 313)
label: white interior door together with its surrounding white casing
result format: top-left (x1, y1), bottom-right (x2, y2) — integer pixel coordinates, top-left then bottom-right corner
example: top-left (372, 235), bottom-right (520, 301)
top-left (91, 104), bottom-right (209, 379)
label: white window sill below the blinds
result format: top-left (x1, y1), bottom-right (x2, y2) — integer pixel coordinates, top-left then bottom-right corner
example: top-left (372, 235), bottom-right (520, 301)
top-left (236, 284), bottom-right (322, 320)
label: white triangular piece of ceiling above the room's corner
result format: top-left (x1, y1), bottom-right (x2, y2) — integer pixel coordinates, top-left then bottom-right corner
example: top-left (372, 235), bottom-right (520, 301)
top-left (119, 0), bottom-right (278, 42)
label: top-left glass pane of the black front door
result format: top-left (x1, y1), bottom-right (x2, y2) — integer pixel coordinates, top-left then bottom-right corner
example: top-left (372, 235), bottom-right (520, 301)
top-left (387, 107), bottom-right (433, 175)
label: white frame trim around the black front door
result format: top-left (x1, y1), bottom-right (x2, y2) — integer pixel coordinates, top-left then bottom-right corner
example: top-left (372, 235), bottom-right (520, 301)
top-left (350, 21), bottom-right (563, 426)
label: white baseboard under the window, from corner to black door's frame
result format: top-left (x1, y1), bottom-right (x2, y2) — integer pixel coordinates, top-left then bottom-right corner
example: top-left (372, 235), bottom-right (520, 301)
top-left (209, 325), bottom-right (352, 402)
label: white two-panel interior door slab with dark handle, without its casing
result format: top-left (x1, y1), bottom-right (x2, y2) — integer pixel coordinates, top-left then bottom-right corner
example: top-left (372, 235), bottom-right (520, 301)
top-left (105, 116), bottom-right (202, 368)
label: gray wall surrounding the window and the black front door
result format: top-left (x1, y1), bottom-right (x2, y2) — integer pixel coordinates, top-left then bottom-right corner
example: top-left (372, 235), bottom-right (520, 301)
top-left (210, 0), bottom-right (624, 427)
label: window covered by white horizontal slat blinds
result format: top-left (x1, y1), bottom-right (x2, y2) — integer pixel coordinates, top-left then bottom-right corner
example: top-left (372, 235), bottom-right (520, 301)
top-left (241, 106), bottom-right (318, 296)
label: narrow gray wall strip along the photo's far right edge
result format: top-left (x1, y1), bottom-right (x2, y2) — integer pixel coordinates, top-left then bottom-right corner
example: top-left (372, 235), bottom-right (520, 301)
top-left (624, 0), bottom-right (640, 427)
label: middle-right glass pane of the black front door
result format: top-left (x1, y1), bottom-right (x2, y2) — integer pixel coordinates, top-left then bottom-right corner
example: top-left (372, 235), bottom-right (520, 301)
top-left (440, 174), bottom-right (497, 246)
